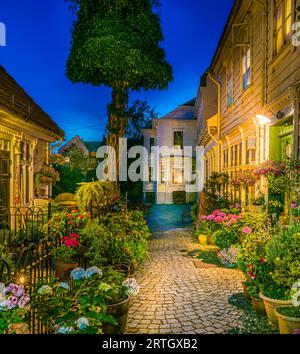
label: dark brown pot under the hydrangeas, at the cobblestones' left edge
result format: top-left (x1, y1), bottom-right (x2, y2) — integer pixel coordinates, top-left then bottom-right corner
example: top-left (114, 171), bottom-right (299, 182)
top-left (103, 297), bottom-right (130, 334)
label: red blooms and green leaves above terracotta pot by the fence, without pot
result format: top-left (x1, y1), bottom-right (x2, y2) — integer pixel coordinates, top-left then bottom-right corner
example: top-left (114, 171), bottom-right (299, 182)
top-left (52, 234), bottom-right (80, 263)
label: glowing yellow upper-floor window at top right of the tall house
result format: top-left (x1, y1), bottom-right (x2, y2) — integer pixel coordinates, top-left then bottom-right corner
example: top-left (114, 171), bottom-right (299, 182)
top-left (274, 0), bottom-right (292, 55)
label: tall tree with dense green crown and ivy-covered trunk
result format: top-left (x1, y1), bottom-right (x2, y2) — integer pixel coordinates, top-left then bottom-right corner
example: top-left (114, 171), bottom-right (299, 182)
top-left (66, 0), bottom-right (173, 183)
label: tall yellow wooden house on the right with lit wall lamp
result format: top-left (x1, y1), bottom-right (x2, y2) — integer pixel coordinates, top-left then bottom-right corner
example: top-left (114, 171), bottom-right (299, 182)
top-left (196, 0), bottom-right (300, 200)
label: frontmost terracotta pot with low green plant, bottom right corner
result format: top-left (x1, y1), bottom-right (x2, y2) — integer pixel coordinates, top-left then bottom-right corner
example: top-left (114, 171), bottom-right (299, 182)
top-left (275, 306), bottom-right (300, 334)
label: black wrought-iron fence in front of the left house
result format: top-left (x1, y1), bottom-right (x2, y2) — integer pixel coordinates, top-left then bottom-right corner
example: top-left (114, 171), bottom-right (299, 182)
top-left (0, 208), bottom-right (87, 334)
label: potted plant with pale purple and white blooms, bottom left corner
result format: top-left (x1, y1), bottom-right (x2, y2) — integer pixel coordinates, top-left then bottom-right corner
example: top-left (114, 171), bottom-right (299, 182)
top-left (0, 283), bottom-right (30, 334)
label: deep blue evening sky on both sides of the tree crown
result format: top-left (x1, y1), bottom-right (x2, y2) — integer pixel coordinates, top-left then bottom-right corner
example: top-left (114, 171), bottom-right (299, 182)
top-left (0, 0), bottom-right (233, 141)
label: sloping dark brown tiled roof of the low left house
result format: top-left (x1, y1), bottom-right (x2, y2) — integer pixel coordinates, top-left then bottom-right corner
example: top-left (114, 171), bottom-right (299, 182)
top-left (0, 65), bottom-right (65, 137)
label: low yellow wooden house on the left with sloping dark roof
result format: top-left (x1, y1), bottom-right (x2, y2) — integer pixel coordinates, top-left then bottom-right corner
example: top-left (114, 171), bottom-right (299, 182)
top-left (0, 66), bottom-right (64, 208)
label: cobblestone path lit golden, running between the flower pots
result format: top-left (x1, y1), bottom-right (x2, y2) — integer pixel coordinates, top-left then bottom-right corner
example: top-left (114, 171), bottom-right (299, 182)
top-left (127, 229), bottom-right (243, 334)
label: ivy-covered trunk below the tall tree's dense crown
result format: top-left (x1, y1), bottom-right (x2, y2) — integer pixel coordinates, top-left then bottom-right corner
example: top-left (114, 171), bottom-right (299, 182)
top-left (107, 84), bottom-right (128, 188)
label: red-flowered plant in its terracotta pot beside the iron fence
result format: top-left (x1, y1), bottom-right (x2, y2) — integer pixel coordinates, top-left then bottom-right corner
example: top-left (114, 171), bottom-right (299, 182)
top-left (51, 234), bottom-right (80, 281)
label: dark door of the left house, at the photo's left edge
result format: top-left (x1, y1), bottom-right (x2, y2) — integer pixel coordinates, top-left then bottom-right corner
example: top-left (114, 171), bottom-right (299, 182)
top-left (0, 151), bottom-right (10, 209)
